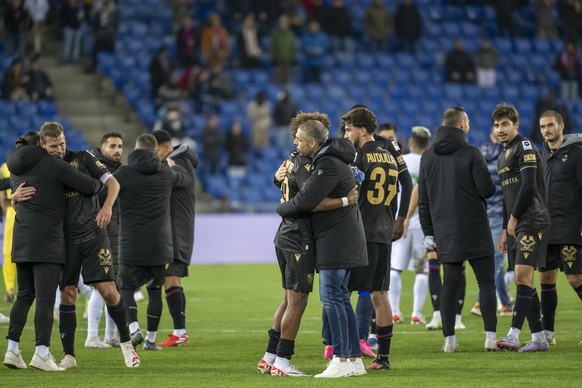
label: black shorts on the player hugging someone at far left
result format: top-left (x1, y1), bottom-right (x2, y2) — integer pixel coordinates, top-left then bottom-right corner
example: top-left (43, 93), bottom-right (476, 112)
top-left (59, 229), bottom-right (115, 290)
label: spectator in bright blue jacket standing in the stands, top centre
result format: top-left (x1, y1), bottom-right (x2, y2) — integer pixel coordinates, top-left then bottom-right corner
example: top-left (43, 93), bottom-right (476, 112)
top-left (301, 20), bottom-right (329, 83)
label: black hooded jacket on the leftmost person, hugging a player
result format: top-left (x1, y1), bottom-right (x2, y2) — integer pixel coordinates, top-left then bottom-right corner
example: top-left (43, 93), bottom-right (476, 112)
top-left (7, 146), bottom-right (101, 264)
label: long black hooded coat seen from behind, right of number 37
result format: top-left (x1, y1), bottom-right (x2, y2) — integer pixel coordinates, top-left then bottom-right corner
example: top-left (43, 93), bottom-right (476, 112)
top-left (418, 127), bottom-right (495, 263)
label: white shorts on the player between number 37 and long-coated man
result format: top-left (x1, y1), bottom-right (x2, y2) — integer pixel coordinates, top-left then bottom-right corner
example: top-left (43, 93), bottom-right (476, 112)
top-left (390, 229), bottom-right (428, 273)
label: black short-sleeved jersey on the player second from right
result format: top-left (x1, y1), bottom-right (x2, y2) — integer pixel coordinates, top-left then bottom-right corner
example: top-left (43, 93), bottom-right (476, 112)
top-left (497, 135), bottom-right (550, 232)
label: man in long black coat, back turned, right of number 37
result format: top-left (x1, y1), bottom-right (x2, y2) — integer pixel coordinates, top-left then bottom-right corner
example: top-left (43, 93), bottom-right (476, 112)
top-left (418, 107), bottom-right (497, 352)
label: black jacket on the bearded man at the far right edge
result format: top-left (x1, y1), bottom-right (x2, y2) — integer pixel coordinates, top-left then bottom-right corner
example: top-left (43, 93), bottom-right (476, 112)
top-left (541, 134), bottom-right (582, 245)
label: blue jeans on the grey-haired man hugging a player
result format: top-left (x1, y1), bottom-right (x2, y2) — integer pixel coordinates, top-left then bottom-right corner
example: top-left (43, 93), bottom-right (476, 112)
top-left (319, 269), bottom-right (361, 357)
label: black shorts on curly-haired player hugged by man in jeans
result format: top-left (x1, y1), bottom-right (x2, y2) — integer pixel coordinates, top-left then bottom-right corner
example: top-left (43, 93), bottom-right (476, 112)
top-left (275, 247), bottom-right (315, 294)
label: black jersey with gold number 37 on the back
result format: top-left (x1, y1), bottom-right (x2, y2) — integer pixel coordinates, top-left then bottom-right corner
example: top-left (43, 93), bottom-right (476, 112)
top-left (354, 141), bottom-right (398, 244)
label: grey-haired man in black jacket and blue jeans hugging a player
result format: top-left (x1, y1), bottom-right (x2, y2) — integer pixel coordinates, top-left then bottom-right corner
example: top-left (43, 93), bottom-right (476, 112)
top-left (277, 120), bottom-right (368, 377)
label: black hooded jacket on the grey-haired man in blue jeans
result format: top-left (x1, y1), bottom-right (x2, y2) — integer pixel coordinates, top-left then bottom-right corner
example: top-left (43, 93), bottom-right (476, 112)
top-left (277, 138), bottom-right (368, 270)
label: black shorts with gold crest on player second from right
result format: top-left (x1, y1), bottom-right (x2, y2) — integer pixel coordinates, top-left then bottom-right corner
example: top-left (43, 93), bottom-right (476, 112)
top-left (507, 228), bottom-right (550, 268)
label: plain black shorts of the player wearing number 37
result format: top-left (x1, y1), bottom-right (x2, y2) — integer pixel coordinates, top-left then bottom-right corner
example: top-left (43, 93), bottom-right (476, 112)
top-left (348, 241), bottom-right (392, 292)
